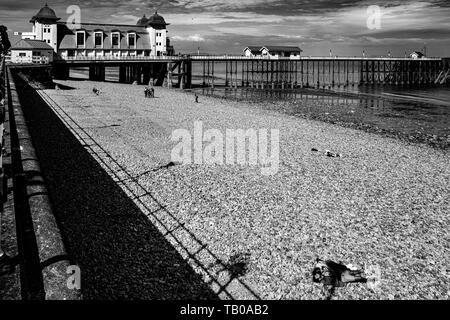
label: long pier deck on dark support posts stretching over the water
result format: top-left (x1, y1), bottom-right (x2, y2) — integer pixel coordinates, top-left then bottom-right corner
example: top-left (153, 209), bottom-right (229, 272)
top-left (53, 55), bottom-right (450, 89)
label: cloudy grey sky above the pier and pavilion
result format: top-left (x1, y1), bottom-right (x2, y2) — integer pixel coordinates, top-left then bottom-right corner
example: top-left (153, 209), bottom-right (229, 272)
top-left (0, 0), bottom-right (450, 57)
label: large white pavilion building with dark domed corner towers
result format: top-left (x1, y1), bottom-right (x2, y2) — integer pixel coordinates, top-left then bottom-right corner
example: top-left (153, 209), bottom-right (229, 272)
top-left (14, 4), bottom-right (173, 58)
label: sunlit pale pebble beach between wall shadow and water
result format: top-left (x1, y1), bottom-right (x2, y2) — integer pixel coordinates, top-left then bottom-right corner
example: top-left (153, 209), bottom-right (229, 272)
top-left (32, 80), bottom-right (450, 300)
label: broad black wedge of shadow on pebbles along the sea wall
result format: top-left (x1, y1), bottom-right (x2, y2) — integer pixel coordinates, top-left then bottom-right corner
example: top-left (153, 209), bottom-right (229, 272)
top-left (15, 72), bottom-right (217, 299)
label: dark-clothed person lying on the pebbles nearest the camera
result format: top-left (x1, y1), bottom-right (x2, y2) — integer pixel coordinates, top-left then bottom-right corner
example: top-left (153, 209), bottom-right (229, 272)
top-left (312, 258), bottom-right (367, 300)
